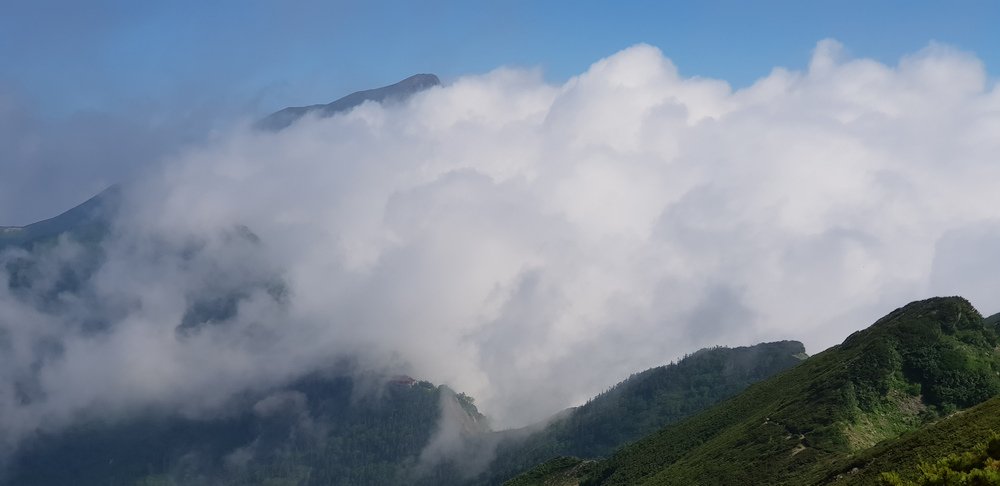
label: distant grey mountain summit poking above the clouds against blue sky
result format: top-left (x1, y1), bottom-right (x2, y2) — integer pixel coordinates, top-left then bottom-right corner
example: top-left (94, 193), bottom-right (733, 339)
top-left (257, 74), bottom-right (441, 131)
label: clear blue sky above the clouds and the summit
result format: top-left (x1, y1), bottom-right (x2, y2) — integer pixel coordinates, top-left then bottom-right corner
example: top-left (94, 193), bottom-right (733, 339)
top-left (0, 0), bottom-right (1000, 115)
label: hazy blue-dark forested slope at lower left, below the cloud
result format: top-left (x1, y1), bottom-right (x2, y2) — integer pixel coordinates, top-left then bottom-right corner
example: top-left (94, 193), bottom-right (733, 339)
top-left (4, 376), bottom-right (487, 486)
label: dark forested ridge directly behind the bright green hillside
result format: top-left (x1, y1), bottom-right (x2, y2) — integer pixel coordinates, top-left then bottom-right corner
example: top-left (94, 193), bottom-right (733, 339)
top-left (485, 341), bottom-right (805, 483)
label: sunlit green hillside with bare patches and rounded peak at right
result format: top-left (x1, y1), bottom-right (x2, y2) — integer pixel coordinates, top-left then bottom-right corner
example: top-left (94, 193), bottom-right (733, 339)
top-left (516, 297), bottom-right (1000, 485)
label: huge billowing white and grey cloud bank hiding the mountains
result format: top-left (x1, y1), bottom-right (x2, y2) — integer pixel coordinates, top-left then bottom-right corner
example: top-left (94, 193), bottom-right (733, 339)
top-left (0, 40), bottom-right (1000, 448)
